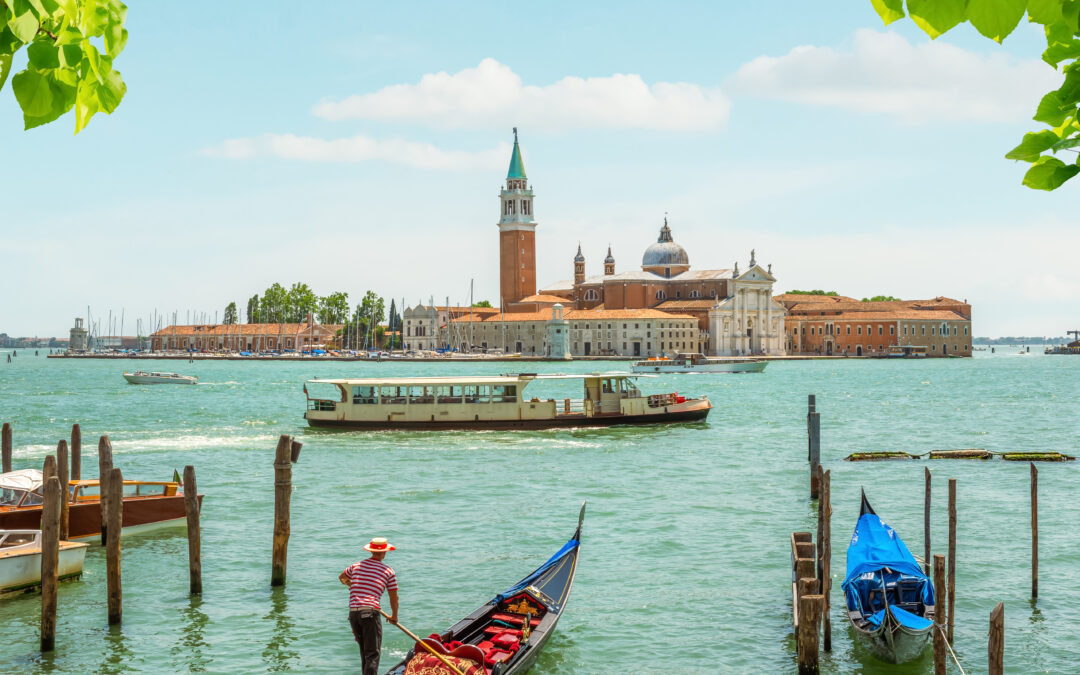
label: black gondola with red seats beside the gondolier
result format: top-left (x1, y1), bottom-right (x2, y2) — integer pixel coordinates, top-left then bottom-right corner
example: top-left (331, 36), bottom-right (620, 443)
top-left (387, 503), bottom-right (585, 675)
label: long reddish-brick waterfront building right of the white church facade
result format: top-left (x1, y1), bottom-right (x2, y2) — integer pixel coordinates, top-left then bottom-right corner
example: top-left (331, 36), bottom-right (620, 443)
top-left (773, 294), bottom-right (972, 356)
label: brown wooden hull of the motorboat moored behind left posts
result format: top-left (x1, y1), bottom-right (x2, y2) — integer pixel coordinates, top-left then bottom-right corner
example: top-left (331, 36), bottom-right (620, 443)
top-left (0, 495), bottom-right (203, 539)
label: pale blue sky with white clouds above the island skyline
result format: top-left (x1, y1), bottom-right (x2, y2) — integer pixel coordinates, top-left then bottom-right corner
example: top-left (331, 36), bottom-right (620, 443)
top-left (0, 0), bottom-right (1080, 337)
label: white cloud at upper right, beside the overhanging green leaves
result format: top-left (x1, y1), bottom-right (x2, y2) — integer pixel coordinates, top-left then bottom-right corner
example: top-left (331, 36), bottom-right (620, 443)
top-left (730, 28), bottom-right (1062, 123)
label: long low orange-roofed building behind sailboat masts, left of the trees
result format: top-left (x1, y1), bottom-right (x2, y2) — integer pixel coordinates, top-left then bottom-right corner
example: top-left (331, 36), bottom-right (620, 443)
top-left (150, 315), bottom-right (342, 351)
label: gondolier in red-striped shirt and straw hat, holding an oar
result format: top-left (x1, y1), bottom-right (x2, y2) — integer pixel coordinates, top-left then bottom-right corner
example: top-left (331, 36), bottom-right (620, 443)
top-left (338, 537), bottom-right (397, 675)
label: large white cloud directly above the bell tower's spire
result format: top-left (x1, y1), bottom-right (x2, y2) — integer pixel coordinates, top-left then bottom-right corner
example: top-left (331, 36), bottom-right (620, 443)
top-left (314, 58), bottom-right (731, 131)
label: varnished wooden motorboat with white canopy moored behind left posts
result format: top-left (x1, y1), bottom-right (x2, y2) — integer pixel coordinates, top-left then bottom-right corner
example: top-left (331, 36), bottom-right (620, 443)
top-left (0, 469), bottom-right (203, 539)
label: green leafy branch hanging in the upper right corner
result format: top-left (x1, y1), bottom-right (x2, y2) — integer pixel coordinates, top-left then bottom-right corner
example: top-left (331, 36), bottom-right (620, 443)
top-left (870, 0), bottom-right (1080, 190)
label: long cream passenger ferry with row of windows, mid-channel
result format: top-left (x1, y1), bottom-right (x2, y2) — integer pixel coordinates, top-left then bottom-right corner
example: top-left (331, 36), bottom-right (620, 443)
top-left (303, 373), bottom-right (713, 429)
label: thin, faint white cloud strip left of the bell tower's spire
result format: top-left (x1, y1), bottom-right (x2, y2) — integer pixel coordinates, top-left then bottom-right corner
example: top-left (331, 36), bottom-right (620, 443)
top-left (202, 134), bottom-right (511, 171)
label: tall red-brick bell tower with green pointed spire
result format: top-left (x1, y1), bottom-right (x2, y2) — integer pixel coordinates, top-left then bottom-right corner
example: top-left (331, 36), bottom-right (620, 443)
top-left (499, 126), bottom-right (537, 303)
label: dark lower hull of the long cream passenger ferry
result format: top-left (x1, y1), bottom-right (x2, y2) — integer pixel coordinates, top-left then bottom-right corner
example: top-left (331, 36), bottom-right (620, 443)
top-left (308, 406), bottom-right (712, 431)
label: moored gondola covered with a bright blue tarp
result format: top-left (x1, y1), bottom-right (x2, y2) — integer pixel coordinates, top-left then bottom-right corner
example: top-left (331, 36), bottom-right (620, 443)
top-left (841, 494), bottom-right (934, 663)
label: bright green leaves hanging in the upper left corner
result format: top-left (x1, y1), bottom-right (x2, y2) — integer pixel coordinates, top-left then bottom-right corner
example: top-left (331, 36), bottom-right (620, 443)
top-left (0, 0), bottom-right (127, 134)
